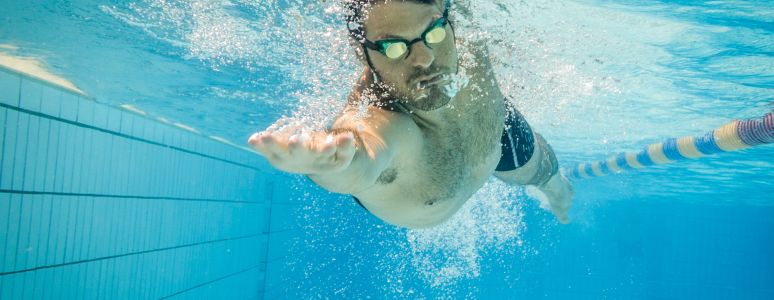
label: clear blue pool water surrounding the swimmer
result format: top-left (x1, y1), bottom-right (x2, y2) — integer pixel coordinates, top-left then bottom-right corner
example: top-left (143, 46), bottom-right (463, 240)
top-left (0, 0), bottom-right (774, 299)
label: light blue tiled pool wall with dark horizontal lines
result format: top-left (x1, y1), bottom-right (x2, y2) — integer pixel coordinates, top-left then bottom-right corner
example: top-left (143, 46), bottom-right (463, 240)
top-left (0, 68), bottom-right (295, 299)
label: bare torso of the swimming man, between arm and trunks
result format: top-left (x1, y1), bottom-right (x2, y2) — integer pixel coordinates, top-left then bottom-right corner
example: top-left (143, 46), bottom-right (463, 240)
top-left (355, 58), bottom-right (505, 228)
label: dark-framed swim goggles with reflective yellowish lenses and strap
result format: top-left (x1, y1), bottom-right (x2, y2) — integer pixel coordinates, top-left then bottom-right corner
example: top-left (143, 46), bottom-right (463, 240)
top-left (362, 0), bottom-right (451, 59)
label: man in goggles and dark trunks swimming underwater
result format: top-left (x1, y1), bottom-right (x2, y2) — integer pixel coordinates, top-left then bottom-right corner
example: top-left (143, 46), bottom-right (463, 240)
top-left (248, 0), bottom-right (573, 228)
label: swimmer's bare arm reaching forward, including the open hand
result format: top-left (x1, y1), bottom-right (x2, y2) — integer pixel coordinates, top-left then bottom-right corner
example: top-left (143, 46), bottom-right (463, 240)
top-left (248, 107), bottom-right (421, 194)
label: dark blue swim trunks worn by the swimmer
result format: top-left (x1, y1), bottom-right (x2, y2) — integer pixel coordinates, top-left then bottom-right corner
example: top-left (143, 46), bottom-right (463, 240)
top-left (352, 109), bottom-right (535, 208)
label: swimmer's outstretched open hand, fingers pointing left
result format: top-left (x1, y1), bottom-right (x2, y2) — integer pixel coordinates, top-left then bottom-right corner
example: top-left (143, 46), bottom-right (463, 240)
top-left (247, 122), bottom-right (356, 175)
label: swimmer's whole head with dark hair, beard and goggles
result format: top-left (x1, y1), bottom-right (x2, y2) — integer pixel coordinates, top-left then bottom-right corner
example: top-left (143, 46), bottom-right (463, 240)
top-left (347, 0), bottom-right (457, 110)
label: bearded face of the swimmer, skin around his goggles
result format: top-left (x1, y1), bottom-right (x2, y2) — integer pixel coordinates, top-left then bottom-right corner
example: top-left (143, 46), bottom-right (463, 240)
top-left (364, 0), bottom-right (457, 110)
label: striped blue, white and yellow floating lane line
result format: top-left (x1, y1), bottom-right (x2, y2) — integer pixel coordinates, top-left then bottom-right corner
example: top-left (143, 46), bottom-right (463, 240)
top-left (562, 111), bottom-right (774, 179)
